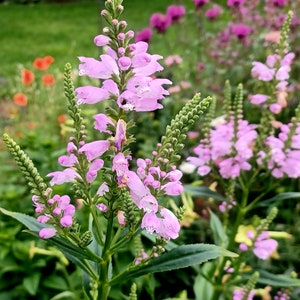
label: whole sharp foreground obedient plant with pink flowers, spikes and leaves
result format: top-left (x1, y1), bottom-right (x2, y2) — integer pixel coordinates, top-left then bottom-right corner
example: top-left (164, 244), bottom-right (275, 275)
top-left (1, 0), bottom-right (234, 299)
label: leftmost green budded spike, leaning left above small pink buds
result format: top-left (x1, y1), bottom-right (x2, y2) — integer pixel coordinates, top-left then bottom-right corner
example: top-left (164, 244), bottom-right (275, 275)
top-left (3, 134), bottom-right (47, 197)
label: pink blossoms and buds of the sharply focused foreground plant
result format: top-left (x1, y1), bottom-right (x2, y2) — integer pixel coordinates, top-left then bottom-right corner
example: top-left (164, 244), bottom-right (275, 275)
top-left (35, 0), bottom-right (183, 240)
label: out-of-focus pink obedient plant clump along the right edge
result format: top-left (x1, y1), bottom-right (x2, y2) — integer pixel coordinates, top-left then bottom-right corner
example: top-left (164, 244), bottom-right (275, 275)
top-left (185, 12), bottom-right (300, 300)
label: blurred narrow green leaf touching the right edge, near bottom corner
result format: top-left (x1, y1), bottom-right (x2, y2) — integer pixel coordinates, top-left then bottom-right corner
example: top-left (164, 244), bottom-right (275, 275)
top-left (257, 270), bottom-right (300, 287)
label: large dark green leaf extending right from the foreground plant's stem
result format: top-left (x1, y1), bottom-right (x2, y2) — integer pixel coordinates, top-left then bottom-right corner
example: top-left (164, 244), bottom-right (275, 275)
top-left (110, 244), bottom-right (238, 285)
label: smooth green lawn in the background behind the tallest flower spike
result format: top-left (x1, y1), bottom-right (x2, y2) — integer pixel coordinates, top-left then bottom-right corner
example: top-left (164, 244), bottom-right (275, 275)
top-left (0, 0), bottom-right (177, 77)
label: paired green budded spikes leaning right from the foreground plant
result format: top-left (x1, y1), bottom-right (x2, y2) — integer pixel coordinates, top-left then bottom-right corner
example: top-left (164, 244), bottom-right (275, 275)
top-left (152, 94), bottom-right (212, 170)
